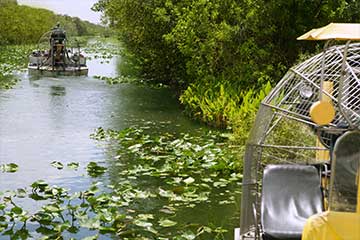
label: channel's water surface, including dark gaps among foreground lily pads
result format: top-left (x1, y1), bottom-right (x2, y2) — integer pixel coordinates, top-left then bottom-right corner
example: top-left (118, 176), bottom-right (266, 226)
top-left (0, 40), bottom-right (240, 239)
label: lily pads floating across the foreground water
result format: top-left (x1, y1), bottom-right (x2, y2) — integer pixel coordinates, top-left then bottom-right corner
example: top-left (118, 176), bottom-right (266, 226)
top-left (0, 123), bottom-right (242, 240)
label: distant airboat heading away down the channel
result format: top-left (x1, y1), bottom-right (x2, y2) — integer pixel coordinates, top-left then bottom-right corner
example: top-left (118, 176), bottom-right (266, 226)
top-left (28, 24), bottom-right (88, 75)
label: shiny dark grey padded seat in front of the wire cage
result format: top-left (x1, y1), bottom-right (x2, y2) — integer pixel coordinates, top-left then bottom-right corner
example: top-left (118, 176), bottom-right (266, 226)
top-left (261, 165), bottom-right (323, 240)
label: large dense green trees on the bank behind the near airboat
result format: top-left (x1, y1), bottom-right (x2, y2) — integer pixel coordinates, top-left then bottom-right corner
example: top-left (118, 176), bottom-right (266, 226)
top-left (94, 0), bottom-right (360, 125)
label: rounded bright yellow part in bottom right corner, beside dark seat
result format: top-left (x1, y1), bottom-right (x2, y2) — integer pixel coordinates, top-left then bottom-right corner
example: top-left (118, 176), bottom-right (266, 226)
top-left (301, 211), bottom-right (360, 240)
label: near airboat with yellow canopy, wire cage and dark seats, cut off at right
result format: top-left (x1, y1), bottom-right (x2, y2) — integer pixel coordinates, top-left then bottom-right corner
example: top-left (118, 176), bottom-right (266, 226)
top-left (235, 23), bottom-right (360, 240)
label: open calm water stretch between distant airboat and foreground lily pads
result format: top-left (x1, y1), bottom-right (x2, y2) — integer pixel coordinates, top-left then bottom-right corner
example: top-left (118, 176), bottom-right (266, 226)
top-left (0, 49), bottom-right (200, 191)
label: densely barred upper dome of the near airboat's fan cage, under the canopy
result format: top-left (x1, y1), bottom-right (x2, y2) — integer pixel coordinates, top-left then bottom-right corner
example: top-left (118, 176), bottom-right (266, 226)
top-left (263, 43), bottom-right (360, 130)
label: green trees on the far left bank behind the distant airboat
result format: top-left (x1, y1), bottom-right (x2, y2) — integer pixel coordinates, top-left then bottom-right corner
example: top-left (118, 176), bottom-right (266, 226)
top-left (0, 0), bottom-right (103, 45)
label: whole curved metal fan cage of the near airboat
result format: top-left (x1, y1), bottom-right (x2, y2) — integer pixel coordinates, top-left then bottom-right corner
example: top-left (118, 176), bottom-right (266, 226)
top-left (240, 43), bottom-right (360, 237)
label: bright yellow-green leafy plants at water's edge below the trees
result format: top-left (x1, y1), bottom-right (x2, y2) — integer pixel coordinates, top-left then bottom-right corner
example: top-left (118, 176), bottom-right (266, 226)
top-left (180, 82), bottom-right (271, 127)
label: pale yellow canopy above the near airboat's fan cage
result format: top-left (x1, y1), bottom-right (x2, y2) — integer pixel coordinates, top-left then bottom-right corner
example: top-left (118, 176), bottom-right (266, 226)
top-left (297, 23), bottom-right (360, 40)
